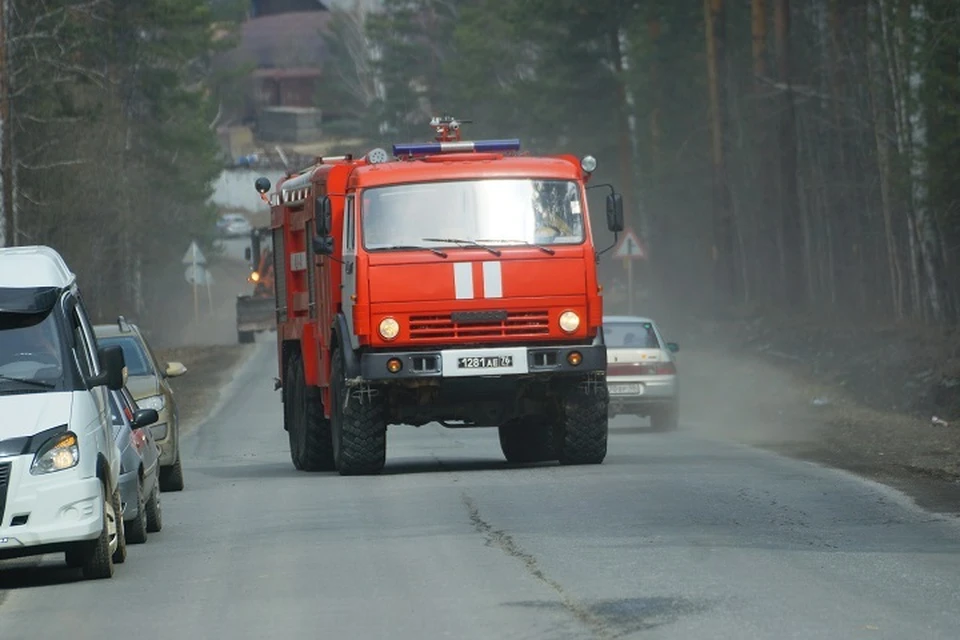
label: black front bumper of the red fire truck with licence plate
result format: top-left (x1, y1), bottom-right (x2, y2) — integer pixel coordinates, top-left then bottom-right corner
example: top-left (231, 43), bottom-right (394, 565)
top-left (360, 344), bottom-right (607, 383)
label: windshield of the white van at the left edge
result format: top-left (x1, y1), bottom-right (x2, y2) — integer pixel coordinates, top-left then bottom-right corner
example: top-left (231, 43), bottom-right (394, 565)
top-left (0, 311), bottom-right (64, 394)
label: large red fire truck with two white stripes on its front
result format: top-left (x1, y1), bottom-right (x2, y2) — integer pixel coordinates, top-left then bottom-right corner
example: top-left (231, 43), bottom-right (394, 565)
top-left (255, 116), bottom-right (623, 475)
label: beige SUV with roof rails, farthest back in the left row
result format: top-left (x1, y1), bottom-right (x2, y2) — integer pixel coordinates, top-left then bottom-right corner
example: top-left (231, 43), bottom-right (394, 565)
top-left (93, 316), bottom-right (187, 491)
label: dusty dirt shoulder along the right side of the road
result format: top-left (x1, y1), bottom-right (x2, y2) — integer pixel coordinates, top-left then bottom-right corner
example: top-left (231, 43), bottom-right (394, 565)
top-left (677, 320), bottom-right (960, 514)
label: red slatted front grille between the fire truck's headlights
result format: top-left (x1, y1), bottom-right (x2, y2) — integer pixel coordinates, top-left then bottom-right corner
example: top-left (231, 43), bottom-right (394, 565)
top-left (410, 311), bottom-right (550, 340)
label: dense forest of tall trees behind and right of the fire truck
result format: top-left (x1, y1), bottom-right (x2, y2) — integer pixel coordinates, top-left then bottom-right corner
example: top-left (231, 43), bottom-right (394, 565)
top-left (319, 0), bottom-right (960, 324)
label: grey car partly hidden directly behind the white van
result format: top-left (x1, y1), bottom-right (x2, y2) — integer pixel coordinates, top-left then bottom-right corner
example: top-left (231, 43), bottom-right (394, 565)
top-left (110, 388), bottom-right (162, 544)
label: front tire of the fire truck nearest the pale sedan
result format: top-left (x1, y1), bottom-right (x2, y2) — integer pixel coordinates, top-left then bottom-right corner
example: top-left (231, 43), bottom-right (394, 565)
top-left (555, 383), bottom-right (610, 465)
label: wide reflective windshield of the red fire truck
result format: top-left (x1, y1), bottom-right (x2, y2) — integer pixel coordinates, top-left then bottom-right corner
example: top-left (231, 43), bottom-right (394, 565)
top-left (361, 178), bottom-right (584, 250)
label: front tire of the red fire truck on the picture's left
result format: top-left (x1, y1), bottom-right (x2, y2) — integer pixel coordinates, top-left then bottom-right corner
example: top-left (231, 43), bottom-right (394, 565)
top-left (330, 349), bottom-right (387, 476)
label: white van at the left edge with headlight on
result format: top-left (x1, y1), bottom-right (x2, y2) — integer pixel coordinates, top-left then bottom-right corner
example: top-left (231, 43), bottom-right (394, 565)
top-left (0, 246), bottom-right (126, 578)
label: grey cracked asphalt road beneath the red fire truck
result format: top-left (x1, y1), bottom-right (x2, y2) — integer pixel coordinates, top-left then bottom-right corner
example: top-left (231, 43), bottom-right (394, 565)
top-left (0, 343), bottom-right (960, 640)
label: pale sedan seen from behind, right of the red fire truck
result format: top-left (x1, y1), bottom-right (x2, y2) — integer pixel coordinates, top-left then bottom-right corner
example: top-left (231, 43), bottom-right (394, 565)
top-left (603, 316), bottom-right (680, 431)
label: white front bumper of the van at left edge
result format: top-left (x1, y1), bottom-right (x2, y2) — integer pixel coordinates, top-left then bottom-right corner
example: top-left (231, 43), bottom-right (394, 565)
top-left (0, 456), bottom-right (103, 558)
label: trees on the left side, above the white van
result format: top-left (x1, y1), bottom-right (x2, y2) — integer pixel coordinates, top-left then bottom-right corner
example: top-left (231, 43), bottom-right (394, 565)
top-left (0, 0), bottom-right (242, 317)
